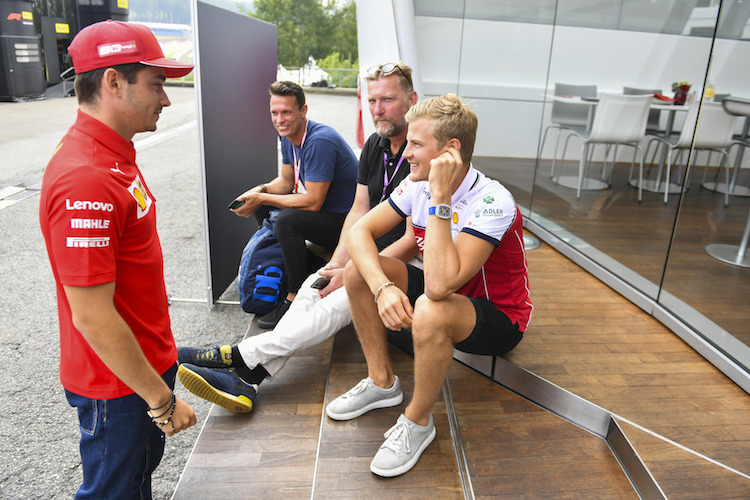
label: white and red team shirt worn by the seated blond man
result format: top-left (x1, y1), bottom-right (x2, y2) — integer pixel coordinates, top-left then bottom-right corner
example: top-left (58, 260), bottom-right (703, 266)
top-left (389, 166), bottom-right (533, 332)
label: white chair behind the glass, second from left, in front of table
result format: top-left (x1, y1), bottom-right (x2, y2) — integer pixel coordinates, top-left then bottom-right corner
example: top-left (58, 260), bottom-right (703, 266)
top-left (560, 93), bottom-right (653, 202)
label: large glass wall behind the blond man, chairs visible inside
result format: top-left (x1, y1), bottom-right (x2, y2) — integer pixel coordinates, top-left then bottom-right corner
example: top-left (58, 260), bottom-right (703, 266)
top-left (414, 0), bottom-right (750, 378)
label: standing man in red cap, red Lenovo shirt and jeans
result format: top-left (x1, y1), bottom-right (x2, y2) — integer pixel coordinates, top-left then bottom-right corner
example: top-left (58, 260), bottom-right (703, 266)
top-left (39, 21), bottom-right (196, 499)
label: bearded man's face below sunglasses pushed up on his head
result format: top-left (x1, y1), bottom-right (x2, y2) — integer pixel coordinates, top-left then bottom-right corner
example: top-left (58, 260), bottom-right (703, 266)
top-left (367, 74), bottom-right (410, 137)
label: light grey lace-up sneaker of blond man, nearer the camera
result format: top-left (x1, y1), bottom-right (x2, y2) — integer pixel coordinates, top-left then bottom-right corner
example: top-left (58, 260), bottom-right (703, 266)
top-left (370, 413), bottom-right (435, 477)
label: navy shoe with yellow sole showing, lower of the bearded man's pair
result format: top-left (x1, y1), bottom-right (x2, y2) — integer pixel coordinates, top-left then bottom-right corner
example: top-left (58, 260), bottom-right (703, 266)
top-left (177, 363), bottom-right (258, 413)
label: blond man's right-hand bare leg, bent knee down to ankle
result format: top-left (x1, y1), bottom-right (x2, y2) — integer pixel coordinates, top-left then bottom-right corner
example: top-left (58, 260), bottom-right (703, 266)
top-left (404, 294), bottom-right (476, 425)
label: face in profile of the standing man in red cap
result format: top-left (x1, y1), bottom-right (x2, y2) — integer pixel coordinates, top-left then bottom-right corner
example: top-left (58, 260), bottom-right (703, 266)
top-left (121, 67), bottom-right (171, 134)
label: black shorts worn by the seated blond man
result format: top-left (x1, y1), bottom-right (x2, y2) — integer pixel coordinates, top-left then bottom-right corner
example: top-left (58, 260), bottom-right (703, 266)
top-left (406, 264), bottom-right (523, 356)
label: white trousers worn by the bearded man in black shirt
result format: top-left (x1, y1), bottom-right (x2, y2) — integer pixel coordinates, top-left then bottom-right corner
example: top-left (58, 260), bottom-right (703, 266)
top-left (237, 273), bottom-right (352, 377)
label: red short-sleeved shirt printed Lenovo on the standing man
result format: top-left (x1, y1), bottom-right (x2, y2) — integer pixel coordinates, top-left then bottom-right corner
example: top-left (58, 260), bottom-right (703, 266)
top-left (39, 111), bottom-right (177, 399)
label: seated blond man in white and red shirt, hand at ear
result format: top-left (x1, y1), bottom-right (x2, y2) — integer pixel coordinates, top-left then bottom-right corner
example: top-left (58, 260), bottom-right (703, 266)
top-left (326, 94), bottom-right (532, 477)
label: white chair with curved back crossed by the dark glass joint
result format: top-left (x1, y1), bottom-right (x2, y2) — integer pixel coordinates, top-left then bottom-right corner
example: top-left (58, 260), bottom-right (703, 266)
top-left (646, 99), bottom-right (737, 204)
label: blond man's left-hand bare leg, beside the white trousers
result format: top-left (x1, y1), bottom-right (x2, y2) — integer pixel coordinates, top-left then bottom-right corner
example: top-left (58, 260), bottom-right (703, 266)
top-left (344, 256), bottom-right (409, 389)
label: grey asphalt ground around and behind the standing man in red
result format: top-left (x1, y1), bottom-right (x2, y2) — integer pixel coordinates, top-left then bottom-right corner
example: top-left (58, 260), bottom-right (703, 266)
top-left (0, 87), bottom-right (366, 499)
